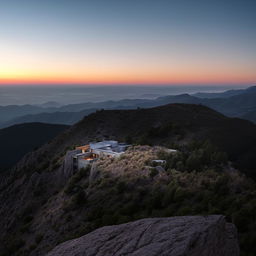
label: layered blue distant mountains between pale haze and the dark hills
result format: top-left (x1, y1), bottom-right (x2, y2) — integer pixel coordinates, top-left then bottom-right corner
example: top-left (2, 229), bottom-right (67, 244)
top-left (0, 86), bottom-right (256, 128)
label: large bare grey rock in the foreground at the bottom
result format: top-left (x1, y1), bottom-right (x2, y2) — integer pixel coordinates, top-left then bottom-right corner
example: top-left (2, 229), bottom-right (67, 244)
top-left (47, 215), bottom-right (239, 256)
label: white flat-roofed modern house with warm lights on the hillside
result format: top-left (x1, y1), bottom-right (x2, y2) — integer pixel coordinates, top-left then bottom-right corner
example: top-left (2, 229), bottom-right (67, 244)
top-left (73, 140), bottom-right (130, 170)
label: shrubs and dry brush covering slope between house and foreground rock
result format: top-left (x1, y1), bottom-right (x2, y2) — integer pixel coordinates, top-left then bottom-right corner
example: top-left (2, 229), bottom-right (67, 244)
top-left (2, 146), bottom-right (256, 255)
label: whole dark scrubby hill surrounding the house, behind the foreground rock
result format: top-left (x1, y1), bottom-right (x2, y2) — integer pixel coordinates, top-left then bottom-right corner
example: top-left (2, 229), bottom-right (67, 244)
top-left (0, 104), bottom-right (256, 256)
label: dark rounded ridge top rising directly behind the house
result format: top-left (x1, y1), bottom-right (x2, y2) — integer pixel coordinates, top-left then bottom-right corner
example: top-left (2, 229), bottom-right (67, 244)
top-left (8, 104), bottom-right (256, 179)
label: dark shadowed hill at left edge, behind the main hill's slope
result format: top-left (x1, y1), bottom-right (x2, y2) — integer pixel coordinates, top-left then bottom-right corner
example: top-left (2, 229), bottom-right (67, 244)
top-left (0, 123), bottom-right (68, 169)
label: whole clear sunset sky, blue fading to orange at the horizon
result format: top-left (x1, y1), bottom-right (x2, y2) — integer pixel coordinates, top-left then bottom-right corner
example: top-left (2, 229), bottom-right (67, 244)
top-left (0, 0), bottom-right (256, 84)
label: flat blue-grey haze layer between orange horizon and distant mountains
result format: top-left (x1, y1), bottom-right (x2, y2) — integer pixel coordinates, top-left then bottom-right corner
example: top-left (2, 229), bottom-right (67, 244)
top-left (0, 85), bottom-right (247, 106)
